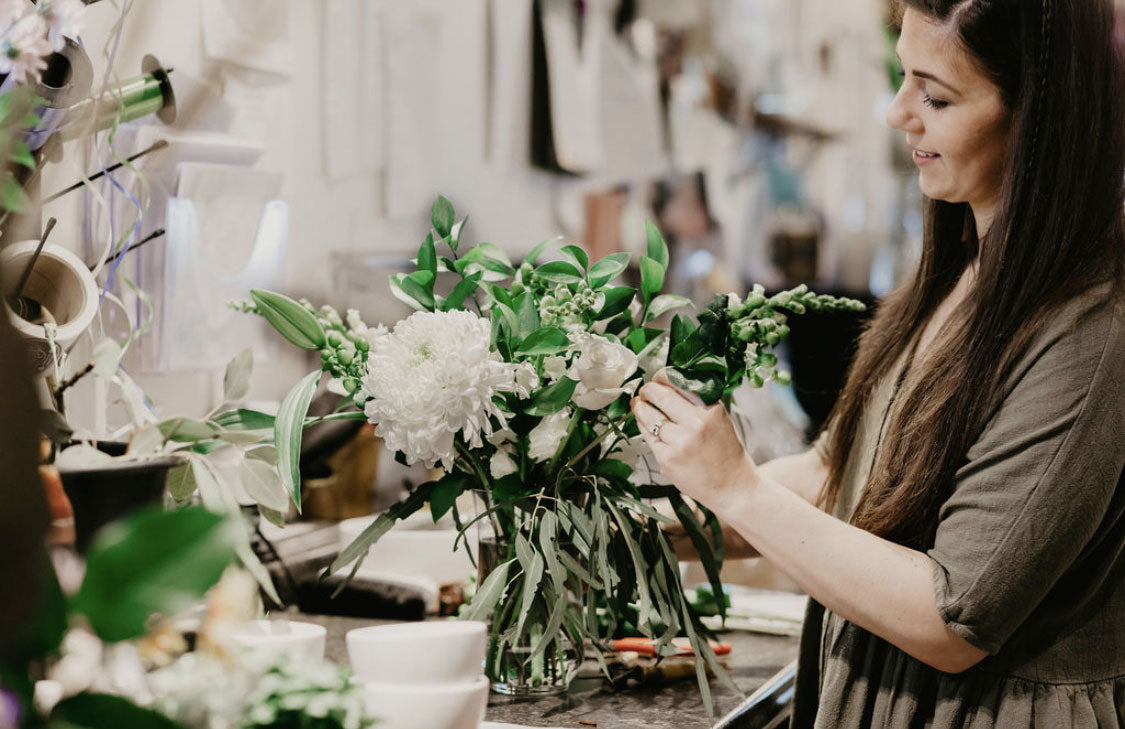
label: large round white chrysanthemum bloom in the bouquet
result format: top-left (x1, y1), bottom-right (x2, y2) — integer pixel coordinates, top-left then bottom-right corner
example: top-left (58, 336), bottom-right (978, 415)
top-left (363, 312), bottom-right (528, 471)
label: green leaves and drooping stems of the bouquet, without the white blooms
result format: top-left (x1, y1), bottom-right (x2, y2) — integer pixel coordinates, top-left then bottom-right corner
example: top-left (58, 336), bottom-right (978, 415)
top-left (246, 197), bottom-right (863, 707)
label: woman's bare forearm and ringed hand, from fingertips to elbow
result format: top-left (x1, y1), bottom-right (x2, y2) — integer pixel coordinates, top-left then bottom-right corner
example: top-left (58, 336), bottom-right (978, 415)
top-left (633, 381), bottom-right (988, 673)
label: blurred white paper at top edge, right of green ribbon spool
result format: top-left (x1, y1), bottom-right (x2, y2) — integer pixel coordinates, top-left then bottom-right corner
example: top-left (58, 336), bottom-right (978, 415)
top-left (199, 0), bottom-right (294, 77)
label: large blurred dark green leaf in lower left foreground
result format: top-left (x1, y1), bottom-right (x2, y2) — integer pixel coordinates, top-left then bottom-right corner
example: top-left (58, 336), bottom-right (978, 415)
top-left (72, 509), bottom-right (237, 642)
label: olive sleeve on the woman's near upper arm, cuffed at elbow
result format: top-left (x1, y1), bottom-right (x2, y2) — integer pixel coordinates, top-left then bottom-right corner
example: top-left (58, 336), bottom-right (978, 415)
top-left (928, 294), bottom-right (1125, 654)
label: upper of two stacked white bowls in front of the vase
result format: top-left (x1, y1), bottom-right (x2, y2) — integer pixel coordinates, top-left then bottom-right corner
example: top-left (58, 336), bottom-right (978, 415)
top-left (347, 620), bottom-right (488, 684)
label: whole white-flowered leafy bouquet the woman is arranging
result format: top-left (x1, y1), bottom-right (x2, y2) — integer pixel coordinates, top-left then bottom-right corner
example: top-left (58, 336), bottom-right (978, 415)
top-left (236, 197), bottom-right (863, 705)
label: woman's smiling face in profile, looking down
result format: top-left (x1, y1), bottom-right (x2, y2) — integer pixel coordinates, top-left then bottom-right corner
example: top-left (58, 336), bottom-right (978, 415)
top-left (887, 9), bottom-right (1011, 216)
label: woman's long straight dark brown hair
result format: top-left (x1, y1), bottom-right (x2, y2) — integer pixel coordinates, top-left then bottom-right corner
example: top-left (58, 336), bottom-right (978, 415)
top-left (822, 0), bottom-right (1125, 549)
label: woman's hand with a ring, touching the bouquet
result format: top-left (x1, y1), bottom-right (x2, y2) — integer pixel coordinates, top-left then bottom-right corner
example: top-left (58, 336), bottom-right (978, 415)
top-left (632, 370), bottom-right (757, 514)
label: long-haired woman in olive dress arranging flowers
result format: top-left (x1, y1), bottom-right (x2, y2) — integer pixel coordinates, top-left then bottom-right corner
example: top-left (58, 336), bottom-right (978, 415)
top-left (633, 0), bottom-right (1125, 729)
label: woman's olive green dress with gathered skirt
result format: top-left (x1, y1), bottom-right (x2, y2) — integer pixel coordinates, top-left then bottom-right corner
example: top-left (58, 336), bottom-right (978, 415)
top-left (792, 287), bottom-right (1125, 729)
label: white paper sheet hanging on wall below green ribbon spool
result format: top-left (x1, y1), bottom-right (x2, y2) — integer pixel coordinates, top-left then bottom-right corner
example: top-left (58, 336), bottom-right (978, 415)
top-left (155, 163), bottom-right (289, 371)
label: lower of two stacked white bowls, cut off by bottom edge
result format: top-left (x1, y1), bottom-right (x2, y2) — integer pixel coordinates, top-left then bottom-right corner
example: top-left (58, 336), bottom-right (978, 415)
top-left (363, 677), bottom-right (489, 729)
